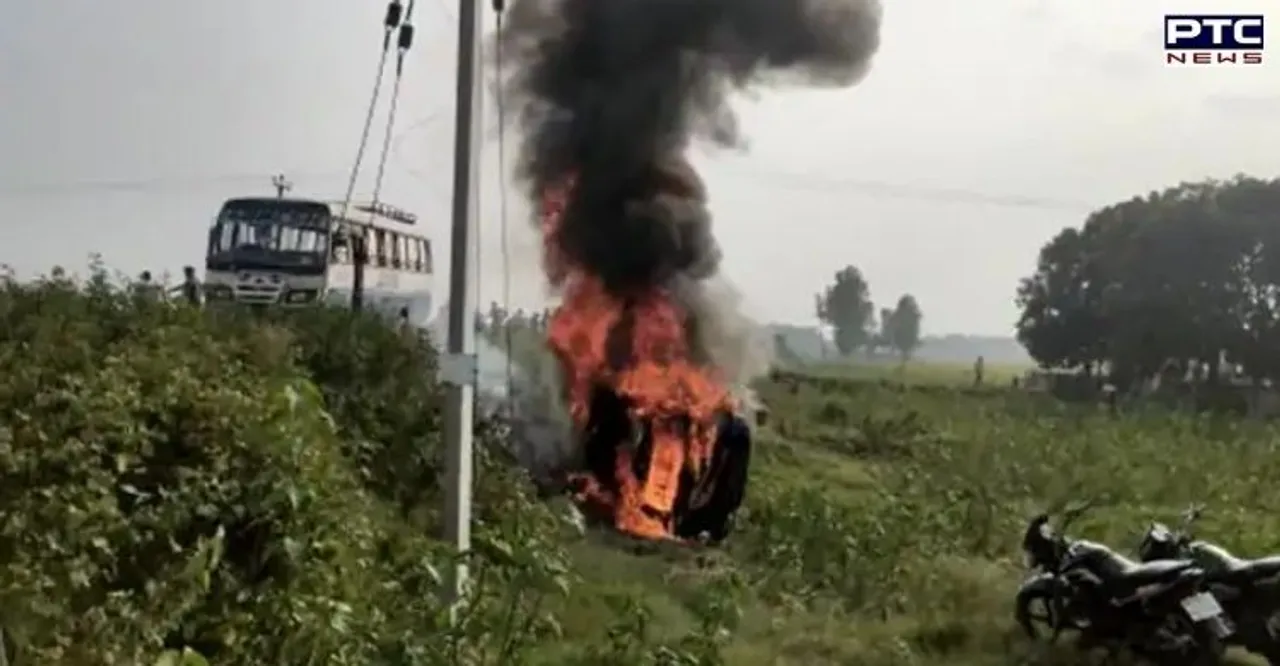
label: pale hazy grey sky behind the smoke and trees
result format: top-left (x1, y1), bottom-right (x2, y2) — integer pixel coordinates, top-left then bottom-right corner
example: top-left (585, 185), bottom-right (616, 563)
top-left (0, 0), bottom-right (1280, 334)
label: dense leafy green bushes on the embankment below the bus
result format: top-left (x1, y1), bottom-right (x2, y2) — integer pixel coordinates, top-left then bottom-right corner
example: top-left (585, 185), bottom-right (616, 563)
top-left (0, 270), bottom-right (567, 666)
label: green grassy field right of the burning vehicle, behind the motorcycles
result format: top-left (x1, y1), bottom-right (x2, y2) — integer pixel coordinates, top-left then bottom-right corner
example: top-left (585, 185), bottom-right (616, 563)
top-left (542, 369), bottom-right (1280, 666)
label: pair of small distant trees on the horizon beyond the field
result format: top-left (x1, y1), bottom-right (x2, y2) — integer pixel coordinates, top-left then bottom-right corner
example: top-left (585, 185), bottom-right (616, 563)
top-left (814, 265), bottom-right (924, 362)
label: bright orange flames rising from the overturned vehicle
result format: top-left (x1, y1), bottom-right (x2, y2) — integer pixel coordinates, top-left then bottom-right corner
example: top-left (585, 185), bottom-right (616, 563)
top-left (541, 179), bottom-right (730, 539)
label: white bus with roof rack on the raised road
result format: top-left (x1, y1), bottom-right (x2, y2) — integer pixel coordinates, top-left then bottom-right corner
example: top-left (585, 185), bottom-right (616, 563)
top-left (205, 197), bottom-right (434, 324)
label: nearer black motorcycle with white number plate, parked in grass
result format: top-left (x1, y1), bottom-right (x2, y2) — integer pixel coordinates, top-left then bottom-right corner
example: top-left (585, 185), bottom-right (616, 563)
top-left (1015, 508), bottom-right (1234, 666)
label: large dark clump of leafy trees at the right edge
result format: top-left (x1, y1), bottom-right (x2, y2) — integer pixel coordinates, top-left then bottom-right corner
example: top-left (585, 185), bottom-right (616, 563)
top-left (1016, 175), bottom-right (1280, 388)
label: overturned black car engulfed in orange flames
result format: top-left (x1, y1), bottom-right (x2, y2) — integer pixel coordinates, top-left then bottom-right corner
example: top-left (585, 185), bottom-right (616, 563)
top-left (543, 175), bottom-right (751, 542)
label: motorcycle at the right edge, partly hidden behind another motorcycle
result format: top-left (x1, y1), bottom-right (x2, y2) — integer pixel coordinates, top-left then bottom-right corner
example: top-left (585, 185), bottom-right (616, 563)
top-left (1138, 505), bottom-right (1280, 666)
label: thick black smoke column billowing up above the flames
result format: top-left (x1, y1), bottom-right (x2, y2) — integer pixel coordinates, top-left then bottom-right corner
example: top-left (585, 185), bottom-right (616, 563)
top-left (498, 0), bottom-right (881, 377)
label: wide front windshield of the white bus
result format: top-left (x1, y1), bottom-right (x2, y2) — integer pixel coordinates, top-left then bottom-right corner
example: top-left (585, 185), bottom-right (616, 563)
top-left (206, 199), bottom-right (329, 272)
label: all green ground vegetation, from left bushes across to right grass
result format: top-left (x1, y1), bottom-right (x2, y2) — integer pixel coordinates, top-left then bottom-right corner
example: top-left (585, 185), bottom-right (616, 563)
top-left (0, 271), bottom-right (1280, 666)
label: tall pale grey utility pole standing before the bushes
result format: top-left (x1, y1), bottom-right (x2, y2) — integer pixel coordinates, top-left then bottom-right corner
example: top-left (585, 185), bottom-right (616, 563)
top-left (440, 0), bottom-right (483, 619)
